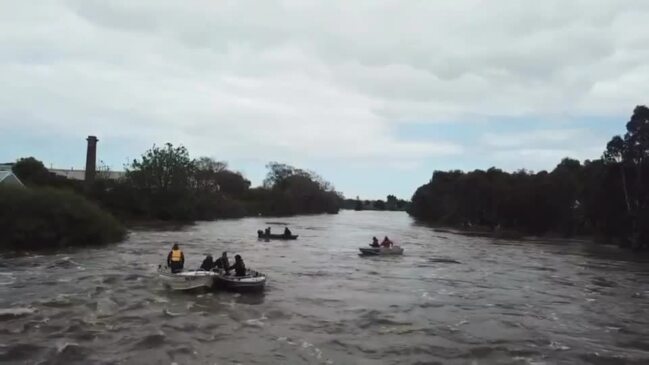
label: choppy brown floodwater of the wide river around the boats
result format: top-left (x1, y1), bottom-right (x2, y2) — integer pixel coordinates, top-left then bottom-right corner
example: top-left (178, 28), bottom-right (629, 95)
top-left (0, 211), bottom-right (649, 364)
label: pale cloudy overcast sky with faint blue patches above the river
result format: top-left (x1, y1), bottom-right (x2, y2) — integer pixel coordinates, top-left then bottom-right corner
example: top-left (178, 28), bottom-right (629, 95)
top-left (0, 0), bottom-right (649, 199)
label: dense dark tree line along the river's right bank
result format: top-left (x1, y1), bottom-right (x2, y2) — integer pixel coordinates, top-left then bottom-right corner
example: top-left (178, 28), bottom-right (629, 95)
top-left (409, 106), bottom-right (649, 248)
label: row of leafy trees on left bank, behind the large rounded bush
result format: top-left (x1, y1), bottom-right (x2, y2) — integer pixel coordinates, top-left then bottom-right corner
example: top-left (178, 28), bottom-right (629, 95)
top-left (13, 143), bottom-right (342, 221)
